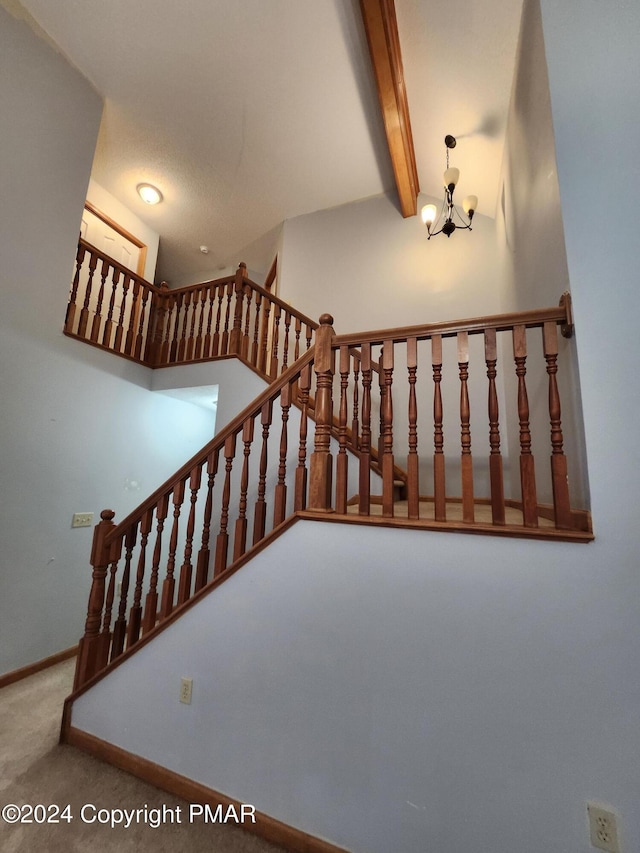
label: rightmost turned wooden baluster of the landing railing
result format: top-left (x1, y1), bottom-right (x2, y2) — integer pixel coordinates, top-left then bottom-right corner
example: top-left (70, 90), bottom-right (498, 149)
top-left (542, 322), bottom-right (573, 530)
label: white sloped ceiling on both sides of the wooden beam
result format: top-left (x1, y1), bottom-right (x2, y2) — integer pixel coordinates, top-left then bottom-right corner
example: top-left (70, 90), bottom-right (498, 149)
top-left (22, 0), bottom-right (522, 281)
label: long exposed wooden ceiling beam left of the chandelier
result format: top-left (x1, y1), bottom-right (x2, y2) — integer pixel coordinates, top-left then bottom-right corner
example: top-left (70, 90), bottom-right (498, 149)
top-left (360, 0), bottom-right (420, 217)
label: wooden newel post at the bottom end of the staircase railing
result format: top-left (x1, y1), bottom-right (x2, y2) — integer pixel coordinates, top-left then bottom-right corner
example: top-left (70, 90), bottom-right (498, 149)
top-left (73, 509), bottom-right (115, 690)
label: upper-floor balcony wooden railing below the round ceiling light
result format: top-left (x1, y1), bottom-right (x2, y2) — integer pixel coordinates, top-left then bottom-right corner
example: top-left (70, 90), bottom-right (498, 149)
top-left (64, 239), bottom-right (318, 381)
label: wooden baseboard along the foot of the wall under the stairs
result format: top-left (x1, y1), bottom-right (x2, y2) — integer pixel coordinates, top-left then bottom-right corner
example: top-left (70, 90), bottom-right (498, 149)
top-left (64, 726), bottom-right (348, 853)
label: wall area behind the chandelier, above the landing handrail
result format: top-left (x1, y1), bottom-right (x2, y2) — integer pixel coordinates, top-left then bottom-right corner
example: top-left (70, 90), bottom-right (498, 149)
top-left (279, 191), bottom-right (501, 334)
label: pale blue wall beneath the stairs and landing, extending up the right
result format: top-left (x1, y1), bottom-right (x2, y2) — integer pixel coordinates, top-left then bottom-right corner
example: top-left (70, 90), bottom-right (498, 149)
top-left (69, 0), bottom-right (640, 853)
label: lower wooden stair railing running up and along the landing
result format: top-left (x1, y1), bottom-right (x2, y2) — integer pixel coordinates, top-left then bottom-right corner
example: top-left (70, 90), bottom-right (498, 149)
top-left (75, 295), bottom-right (593, 689)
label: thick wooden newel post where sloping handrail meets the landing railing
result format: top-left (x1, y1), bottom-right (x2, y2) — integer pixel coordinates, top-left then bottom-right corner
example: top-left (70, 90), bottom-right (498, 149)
top-left (307, 314), bottom-right (335, 512)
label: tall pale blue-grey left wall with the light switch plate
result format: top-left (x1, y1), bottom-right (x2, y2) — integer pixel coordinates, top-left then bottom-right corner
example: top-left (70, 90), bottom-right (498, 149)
top-left (0, 8), bottom-right (212, 672)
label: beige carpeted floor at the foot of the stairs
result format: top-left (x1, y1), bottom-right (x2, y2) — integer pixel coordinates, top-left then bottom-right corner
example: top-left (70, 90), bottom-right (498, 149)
top-left (0, 660), bottom-right (282, 853)
